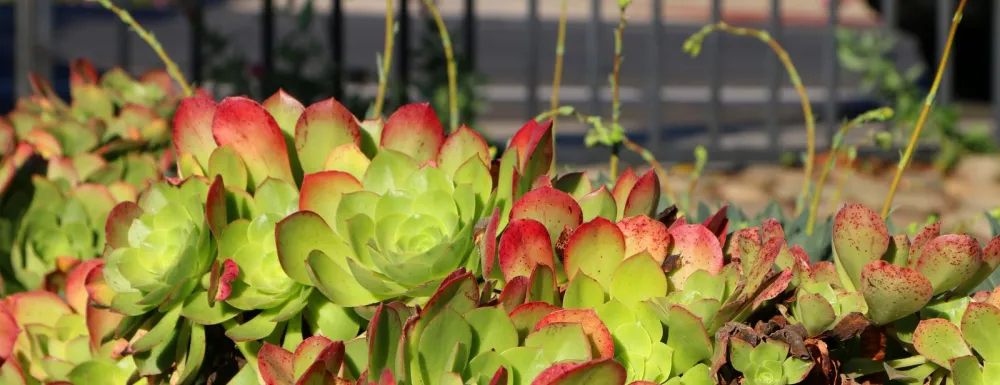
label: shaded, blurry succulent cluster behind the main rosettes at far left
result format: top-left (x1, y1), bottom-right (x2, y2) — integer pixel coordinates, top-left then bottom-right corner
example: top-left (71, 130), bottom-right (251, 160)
top-left (0, 59), bottom-right (197, 291)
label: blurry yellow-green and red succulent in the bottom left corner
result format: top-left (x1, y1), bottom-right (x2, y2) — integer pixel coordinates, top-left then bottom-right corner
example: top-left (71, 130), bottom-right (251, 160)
top-left (0, 260), bottom-right (135, 384)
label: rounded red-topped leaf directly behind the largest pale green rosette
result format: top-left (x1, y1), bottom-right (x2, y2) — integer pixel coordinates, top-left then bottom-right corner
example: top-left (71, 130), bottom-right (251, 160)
top-left (379, 103), bottom-right (445, 164)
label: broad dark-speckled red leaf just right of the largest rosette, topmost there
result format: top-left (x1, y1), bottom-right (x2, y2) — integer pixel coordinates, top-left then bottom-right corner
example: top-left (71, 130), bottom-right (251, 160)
top-left (510, 187), bottom-right (583, 246)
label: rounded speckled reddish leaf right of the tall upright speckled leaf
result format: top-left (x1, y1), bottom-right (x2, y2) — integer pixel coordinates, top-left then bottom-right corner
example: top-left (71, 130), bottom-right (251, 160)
top-left (913, 234), bottom-right (983, 294)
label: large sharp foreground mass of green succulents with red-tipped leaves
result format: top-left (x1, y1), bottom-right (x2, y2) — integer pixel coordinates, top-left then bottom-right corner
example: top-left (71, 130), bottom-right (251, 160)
top-left (0, 79), bottom-right (1000, 385)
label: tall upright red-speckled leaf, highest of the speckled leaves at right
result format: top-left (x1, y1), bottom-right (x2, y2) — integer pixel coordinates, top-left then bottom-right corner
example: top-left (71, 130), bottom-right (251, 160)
top-left (833, 204), bottom-right (889, 287)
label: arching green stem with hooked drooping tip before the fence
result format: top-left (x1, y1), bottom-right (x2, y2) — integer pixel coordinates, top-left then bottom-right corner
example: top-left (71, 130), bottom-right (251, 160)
top-left (684, 22), bottom-right (816, 216)
